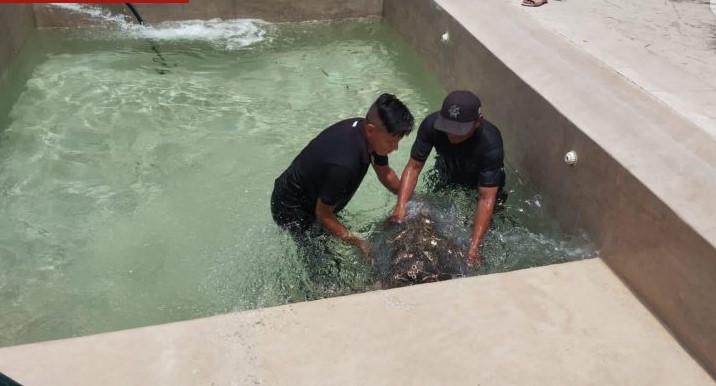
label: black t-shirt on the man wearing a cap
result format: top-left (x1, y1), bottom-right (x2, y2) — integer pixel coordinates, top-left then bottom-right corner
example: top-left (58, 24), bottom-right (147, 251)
top-left (410, 112), bottom-right (505, 187)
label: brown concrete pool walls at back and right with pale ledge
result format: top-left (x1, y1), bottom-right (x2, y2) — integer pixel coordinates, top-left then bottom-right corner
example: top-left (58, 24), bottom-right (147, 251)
top-left (0, 0), bottom-right (716, 380)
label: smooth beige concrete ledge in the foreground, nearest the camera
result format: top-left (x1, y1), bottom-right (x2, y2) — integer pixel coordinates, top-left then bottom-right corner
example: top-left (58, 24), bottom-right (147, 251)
top-left (0, 259), bottom-right (713, 386)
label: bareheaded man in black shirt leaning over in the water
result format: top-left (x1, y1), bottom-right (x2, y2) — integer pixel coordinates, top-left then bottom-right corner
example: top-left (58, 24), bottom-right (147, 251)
top-left (271, 94), bottom-right (413, 255)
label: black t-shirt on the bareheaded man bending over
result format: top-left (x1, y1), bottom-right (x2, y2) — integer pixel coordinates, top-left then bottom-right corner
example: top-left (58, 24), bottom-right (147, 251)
top-left (274, 118), bottom-right (388, 216)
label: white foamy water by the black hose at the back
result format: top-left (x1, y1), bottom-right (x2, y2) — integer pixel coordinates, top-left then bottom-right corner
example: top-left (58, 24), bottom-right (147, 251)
top-left (49, 3), bottom-right (271, 50)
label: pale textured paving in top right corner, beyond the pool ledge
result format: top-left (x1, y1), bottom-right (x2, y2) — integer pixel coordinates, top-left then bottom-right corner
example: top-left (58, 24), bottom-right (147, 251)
top-left (520, 0), bottom-right (716, 142)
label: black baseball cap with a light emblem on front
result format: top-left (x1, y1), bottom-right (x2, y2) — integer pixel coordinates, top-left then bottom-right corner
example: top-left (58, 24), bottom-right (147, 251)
top-left (433, 90), bottom-right (482, 135)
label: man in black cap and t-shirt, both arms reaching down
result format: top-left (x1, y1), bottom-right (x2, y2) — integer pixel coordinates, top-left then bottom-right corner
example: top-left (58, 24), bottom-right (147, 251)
top-left (391, 91), bottom-right (505, 267)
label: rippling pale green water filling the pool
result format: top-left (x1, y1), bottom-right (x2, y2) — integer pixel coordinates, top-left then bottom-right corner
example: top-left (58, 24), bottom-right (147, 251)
top-left (0, 19), bottom-right (595, 346)
